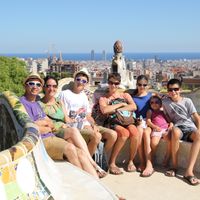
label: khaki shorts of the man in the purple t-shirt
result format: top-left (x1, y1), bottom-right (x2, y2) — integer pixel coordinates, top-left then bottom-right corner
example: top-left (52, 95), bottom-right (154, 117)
top-left (43, 136), bottom-right (67, 160)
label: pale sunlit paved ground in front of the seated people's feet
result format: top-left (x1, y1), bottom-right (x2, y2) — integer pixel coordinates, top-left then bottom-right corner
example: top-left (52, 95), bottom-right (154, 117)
top-left (101, 168), bottom-right (200, 200)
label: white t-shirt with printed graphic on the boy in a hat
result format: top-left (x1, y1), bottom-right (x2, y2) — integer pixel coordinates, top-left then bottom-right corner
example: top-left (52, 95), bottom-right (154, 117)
top-left (58, 90), bottom-right (91, 129)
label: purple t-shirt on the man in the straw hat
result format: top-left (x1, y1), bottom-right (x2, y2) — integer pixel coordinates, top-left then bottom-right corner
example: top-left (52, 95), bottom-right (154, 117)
top-left (20, 96), bottom-right (54, 138)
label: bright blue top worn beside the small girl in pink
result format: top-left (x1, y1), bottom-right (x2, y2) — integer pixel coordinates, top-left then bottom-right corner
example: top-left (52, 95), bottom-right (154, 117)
top-left (133, 92), bottom-right (152, 119)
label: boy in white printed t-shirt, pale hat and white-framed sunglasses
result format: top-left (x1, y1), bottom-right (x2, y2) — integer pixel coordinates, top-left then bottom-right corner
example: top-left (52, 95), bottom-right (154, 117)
top-left (59, 68), bottom-right (117, 155)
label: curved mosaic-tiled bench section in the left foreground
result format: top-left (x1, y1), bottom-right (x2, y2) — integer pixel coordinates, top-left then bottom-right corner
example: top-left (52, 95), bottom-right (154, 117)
top-left (0, 91), bottom-right (116, 200)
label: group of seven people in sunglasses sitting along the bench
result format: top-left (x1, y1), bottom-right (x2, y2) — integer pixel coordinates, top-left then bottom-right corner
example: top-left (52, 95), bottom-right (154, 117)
top-left (20, 69), bottom-right (200, 185)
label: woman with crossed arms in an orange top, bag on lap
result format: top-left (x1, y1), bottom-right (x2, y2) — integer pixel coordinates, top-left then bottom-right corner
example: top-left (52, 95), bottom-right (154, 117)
top-left (99, 73), bottom-right (139, 175)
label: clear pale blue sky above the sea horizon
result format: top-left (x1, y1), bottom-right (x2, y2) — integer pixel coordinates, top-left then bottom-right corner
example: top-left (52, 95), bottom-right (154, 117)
top-left (0, 0), bottom-right (200, 53)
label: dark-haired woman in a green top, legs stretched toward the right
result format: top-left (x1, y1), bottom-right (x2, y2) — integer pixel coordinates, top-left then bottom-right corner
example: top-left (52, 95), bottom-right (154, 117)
top-left (41, 76), bottom-right (105, 178)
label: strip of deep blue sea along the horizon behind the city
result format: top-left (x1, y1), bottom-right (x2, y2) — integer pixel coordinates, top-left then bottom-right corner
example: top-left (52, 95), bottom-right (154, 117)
top-left (0, 52), bottom-right (200, 61)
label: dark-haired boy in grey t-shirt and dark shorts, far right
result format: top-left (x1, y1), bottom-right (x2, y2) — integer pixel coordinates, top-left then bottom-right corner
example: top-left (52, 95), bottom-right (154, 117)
top-left (163, 79), bottom-right (200, 185)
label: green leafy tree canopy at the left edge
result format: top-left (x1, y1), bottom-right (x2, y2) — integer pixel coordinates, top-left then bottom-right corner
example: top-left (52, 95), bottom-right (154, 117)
top-left (0, 56), bottom-right (28, 96)
